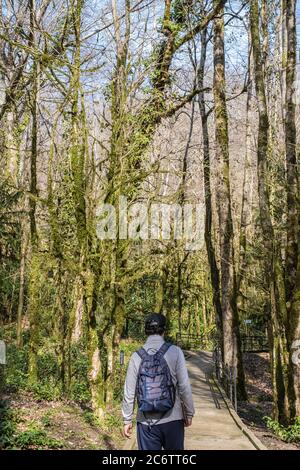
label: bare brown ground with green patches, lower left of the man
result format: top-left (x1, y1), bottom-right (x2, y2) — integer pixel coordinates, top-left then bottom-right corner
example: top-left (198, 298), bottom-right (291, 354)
top-left (0, 392), bottom-right (123, 450)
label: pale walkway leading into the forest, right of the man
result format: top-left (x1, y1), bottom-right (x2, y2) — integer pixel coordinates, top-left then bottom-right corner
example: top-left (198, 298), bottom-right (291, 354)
top-left (185, 351), bottom-right (259, 450)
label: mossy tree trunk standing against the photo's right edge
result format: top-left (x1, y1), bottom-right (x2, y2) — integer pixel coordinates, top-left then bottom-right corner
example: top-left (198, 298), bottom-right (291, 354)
top-left (285, 0), bottom-right (300, 420)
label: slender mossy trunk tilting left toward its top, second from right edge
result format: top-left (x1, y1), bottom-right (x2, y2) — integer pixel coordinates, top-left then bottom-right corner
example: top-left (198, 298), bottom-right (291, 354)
top-left (250, 0), bottom-right (288, 423)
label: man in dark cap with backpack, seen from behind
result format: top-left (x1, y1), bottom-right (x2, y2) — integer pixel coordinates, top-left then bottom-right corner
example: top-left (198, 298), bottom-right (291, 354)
top-left (122, 313), bottom-right (195, 450)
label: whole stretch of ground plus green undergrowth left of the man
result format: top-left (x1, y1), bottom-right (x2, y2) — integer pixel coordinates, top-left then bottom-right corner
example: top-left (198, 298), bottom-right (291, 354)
top-left (0, 324), bottom-right (142, 450)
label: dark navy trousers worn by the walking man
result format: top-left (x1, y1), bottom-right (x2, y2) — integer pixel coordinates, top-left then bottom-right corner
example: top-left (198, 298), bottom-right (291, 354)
top-left (137, 420), bottom-right (184, 450)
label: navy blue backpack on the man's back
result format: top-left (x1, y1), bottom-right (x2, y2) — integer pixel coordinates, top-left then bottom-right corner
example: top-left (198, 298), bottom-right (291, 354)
top-left (136, 343), bottom-right (175, 414)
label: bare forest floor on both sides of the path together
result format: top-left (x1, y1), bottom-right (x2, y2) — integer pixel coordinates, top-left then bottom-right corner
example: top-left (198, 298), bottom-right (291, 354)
top-left (0, 353), bottom-right (300, 450)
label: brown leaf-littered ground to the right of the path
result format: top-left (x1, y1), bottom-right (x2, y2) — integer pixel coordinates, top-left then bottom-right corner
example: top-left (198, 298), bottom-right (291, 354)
top-left (238, 353), bottom-right (300, 450)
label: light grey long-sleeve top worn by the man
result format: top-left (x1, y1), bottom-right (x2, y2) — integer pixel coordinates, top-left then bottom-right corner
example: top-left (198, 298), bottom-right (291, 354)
top-left (122, 335), bottom-right (195, 424)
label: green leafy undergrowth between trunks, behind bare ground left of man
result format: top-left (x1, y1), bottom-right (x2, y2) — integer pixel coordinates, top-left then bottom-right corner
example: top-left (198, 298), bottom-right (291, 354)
top-left (0, 329), bottom-right (142, 407)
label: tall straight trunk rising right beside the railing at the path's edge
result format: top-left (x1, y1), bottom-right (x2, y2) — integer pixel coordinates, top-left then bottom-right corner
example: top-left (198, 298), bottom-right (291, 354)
top-left (214, 1), bottom-right (247, 398)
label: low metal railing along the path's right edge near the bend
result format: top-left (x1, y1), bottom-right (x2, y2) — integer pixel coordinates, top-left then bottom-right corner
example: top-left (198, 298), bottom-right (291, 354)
top-left (213, 348), bottom-right (237, 411)
